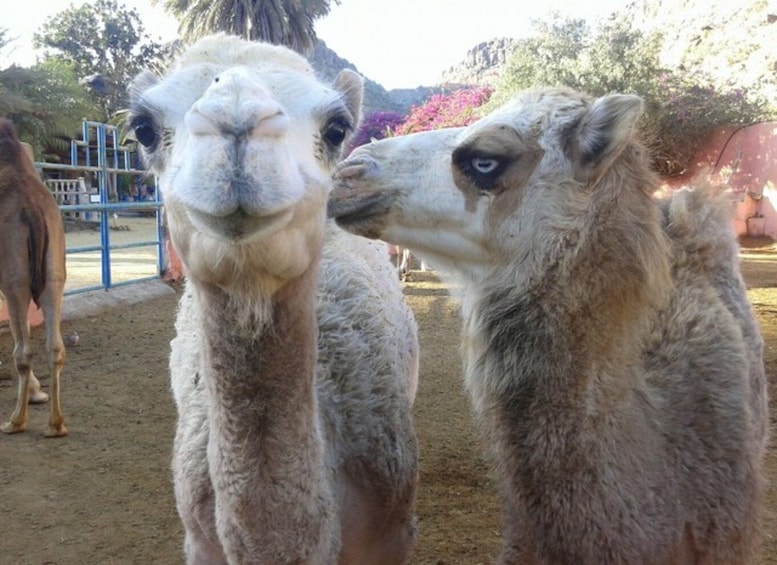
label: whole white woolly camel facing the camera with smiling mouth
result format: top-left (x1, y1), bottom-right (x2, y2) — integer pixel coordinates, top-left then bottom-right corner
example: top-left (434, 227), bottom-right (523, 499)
top-left (129, 35), bottom-right (418, 564)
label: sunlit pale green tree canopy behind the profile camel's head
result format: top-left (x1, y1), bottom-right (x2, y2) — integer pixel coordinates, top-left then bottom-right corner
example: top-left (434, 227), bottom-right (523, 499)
top-left (484, 15), bottom-right (770, 176)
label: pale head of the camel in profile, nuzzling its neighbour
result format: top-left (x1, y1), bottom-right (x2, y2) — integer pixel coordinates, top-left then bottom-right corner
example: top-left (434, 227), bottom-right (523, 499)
top-left (329, 89), bottom-right (652, 280)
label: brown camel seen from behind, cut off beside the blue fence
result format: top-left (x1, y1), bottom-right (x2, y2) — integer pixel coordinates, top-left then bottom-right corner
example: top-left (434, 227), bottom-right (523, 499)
top-left (0, 118), bottom-right (67, 437)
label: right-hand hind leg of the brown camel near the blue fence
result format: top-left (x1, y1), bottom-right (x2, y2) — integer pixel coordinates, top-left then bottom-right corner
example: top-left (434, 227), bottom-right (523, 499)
top-left (40, 281), bottom-right (68, 437)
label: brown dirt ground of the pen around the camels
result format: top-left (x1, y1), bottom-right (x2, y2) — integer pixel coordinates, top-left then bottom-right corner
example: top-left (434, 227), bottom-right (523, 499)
top-left (0, 242), bottom-right (777, 565)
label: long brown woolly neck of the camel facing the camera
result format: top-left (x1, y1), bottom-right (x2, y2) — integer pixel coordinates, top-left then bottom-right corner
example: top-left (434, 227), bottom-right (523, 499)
top-left (194, 268), bottom-right (333, 560)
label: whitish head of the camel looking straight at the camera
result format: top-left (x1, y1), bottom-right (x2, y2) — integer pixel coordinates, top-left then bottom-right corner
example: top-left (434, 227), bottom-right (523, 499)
top-left (129, 34), bottom-right (362, 288)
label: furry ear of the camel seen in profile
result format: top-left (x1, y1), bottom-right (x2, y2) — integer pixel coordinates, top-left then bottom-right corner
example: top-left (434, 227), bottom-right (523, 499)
top-left (570, 94), bottom-right (642, 184)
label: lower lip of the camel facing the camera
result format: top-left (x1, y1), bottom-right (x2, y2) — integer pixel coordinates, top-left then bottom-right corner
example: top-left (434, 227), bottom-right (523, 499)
top-left (189, 209), bottom-right (291, 243)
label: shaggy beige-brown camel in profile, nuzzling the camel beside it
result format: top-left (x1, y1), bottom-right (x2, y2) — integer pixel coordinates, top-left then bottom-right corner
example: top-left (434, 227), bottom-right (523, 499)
top-left (330, 89), bottom-right (768, 565)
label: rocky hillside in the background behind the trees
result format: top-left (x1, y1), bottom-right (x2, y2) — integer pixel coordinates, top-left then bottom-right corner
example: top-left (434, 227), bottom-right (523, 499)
top-left (312, 0), bottom-right (777, 114)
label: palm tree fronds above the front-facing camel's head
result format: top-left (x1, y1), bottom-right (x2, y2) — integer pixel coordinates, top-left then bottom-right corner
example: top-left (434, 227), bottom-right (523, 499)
top-left (152, 0), bottom-right (340, 54)
